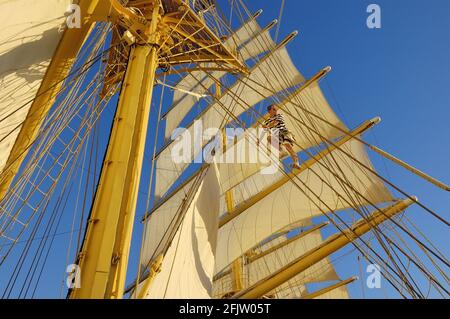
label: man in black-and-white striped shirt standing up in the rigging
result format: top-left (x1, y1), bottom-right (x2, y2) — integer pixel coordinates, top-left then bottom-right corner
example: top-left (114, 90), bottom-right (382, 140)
top-left (257, 104), bottom-right (300, 169)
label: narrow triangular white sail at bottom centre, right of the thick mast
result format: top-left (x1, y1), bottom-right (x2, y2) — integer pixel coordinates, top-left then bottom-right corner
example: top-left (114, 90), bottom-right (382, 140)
top-left (139, 166), bottom-right (219, 299)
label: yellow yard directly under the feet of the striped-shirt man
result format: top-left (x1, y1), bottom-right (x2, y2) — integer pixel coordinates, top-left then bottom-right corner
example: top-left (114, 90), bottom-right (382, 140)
top-left (219, 118), bottom-right (380, 227)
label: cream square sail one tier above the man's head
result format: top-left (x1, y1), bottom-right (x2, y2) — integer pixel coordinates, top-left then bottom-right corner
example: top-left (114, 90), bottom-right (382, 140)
top-left (155, 47), bottom-right (304, 197)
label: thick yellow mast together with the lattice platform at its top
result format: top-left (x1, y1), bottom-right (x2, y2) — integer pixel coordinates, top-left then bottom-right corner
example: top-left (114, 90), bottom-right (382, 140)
top-left (69, 0), bottom-right (245, 298)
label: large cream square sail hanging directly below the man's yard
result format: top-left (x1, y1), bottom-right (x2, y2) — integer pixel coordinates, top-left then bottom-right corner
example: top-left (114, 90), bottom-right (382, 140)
top-left (216, 140), bottom-right (392, 272)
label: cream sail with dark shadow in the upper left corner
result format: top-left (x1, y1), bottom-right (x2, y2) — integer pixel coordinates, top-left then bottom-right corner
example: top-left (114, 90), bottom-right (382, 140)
top-left (0, 0), bottom-right (72, 173)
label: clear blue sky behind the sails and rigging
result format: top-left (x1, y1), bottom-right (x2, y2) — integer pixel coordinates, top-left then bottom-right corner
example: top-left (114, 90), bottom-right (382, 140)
top-left (0, 0), bottom-right (450, 298)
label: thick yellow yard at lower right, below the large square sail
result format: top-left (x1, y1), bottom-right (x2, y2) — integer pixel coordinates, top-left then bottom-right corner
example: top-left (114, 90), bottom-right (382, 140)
top-left (232, 198), bottom-right (417, 299)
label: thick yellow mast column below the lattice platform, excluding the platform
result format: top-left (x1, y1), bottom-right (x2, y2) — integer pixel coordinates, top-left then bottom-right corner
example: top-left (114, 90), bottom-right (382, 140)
top-left (72, 7), bottom-right (159, 298)
